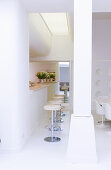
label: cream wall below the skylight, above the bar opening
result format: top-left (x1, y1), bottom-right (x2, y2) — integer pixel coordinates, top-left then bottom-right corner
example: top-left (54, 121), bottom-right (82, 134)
top-left (30, 36), bottom-right (73, 61)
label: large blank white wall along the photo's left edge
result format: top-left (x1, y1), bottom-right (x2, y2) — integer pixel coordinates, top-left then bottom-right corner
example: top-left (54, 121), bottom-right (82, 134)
top-left (0, 0), bottom-right (29, 150)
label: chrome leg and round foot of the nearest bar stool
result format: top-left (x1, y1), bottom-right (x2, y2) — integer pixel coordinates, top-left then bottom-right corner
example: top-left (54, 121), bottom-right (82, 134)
top-left (44, 111), bottom-right (61, 142)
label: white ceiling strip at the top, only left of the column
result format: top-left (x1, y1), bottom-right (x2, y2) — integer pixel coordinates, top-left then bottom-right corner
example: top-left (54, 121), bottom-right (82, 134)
top-left (21, 0), bottom-right (74, 13)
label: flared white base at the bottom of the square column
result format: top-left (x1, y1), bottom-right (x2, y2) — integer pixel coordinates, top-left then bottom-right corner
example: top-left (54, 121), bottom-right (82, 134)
top-left (67, 114), bottom-right (97, 164)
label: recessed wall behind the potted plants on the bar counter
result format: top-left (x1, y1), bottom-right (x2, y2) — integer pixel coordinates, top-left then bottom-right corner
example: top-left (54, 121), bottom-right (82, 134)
top-left (29, 62), bottom-right (59, 83)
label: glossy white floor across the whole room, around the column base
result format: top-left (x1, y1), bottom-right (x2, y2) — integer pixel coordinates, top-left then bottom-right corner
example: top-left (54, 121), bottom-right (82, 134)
top-left (0, 110), bottom-right (111, 170)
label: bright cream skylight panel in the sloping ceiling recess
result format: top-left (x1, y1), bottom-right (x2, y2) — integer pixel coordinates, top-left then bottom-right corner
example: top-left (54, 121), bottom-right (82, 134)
top-left (41, 13), bottom-right (68, 35)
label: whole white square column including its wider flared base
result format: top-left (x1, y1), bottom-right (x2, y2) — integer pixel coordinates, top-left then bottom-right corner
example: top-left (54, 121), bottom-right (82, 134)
top-left (68, 0), bottom-right (97, 163)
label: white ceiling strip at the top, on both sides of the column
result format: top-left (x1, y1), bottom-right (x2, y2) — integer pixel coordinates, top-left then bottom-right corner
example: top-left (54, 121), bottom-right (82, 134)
top-left (21, 0), bottom-right (111, 13)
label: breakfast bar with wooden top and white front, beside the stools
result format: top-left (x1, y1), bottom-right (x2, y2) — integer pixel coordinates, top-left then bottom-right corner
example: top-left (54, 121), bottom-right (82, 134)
top-left (29, 81), bottom-right (59, 129)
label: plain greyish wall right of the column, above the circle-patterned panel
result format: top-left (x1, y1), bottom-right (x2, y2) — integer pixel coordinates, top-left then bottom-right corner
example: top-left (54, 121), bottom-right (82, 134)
top-left (93, 17), bottom-right (111, 60)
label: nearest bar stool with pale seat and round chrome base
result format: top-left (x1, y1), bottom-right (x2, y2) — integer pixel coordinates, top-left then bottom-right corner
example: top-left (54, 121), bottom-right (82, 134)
top-left (44, 104), bottom-right (61, 142)
